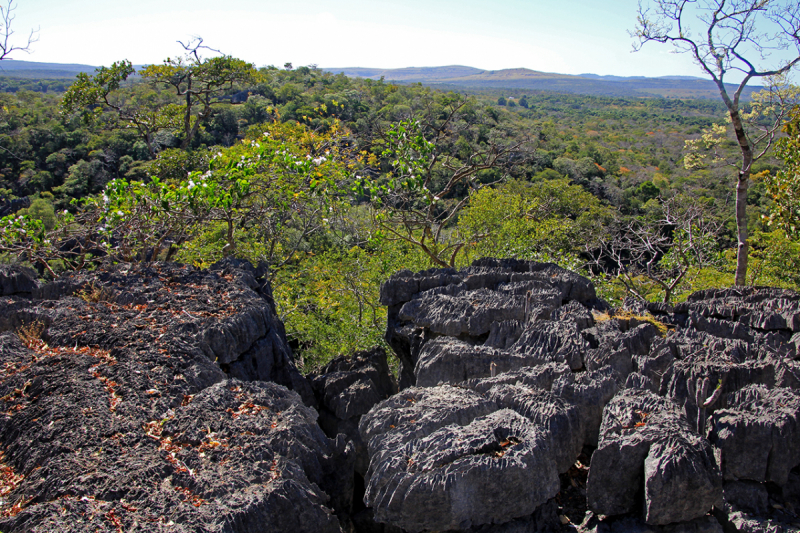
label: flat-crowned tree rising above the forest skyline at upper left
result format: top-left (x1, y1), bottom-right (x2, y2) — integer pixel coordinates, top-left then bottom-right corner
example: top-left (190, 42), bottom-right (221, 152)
top-left (140, 37), bottom-right (256, 150)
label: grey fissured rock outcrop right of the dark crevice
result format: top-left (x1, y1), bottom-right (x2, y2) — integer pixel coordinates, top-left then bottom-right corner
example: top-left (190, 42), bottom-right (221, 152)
top-left (361, 260), bottom-right (800, 532)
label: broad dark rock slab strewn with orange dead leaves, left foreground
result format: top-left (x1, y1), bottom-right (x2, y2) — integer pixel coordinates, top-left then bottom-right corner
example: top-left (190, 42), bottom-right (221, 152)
top-left (0, 262), bottom-right (355, 533)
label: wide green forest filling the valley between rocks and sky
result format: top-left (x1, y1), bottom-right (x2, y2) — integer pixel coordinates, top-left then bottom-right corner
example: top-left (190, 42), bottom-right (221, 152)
top-left (0, 47), bottom-right (800, 370)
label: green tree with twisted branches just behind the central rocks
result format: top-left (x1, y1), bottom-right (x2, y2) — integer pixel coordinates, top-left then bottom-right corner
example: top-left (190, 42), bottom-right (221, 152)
top-left (356, 93), bottom-right (529, 267)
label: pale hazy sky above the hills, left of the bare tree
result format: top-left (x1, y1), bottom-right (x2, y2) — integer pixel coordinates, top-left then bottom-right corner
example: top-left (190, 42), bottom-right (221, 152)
top-left (6, 0), bottom-right (800, 76)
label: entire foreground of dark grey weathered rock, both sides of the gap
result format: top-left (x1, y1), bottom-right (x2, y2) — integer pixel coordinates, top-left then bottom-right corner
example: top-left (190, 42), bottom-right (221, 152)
top-left (0, 260), bottom-right (800, 533)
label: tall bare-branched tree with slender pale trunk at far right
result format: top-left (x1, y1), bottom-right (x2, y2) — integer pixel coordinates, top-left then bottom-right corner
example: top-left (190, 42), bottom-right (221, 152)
top-left (633, 0), bottom-right (800, 285)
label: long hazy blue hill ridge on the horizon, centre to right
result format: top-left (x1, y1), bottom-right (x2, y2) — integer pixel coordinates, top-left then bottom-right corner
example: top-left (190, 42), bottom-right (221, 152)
top-left (324, 65), bottom-right (761, 99)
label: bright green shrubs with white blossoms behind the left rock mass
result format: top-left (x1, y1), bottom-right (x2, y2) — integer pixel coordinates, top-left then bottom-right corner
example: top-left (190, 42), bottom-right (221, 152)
top-left (0, 117), bottom-right (354, 274)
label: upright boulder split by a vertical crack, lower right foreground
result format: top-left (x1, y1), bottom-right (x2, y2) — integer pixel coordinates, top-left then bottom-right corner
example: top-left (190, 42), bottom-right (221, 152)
top-left (587, 389), bottom-right (722, 525)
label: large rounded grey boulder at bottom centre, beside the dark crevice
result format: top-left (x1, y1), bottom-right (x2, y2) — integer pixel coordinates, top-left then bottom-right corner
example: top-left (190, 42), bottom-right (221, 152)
top-left (365, 409), bottom-right (559, 533)
